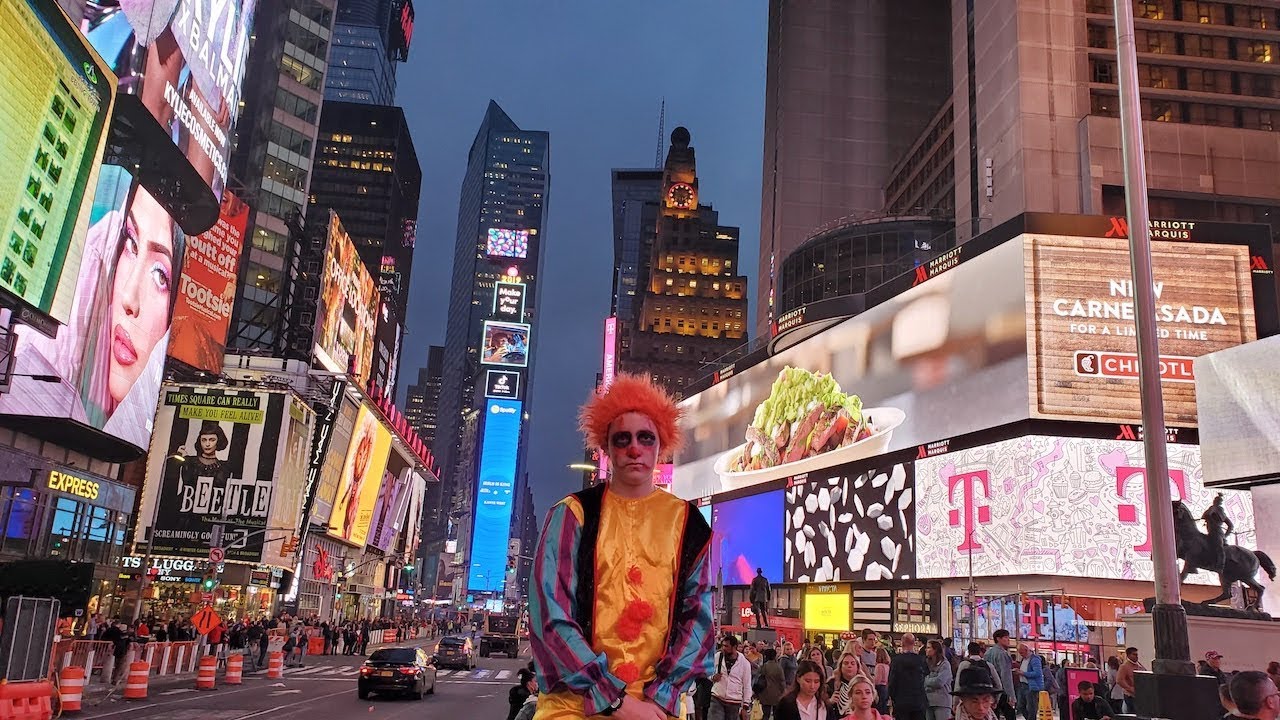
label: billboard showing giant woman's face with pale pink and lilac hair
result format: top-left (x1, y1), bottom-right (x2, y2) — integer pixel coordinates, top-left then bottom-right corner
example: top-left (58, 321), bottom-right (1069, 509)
top-left (0, 165), bottom-right (187, 450)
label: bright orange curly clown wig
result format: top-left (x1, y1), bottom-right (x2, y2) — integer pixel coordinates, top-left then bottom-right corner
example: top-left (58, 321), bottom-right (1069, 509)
top-left (577, 373), bottom-right (685, 457)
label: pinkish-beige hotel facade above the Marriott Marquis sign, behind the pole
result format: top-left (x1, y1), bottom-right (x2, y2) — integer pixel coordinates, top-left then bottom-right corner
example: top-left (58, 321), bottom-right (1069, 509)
top-left (952, 0), bottom-right (1280, 270)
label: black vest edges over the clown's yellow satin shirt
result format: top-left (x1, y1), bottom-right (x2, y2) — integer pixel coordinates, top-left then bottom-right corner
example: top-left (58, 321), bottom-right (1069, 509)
top-left (573, 483), bottom-right (712, 644)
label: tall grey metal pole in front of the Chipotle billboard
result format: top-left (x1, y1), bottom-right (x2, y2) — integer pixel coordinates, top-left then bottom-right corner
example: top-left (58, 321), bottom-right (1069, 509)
top-left (1114, 0), bottom-right (1196, 675)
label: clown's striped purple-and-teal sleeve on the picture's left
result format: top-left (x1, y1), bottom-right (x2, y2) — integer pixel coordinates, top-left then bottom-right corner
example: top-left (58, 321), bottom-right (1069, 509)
top-left (529, 498), bottom-right (626, 716)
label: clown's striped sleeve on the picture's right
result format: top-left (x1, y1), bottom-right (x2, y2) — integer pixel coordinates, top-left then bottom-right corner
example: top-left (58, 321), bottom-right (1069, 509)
top-left (644, 538), bottom-right (716, 717)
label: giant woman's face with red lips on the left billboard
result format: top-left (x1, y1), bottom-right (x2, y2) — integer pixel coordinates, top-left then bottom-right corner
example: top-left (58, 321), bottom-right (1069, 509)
top-left (108, 188), bottom-right (174, 402)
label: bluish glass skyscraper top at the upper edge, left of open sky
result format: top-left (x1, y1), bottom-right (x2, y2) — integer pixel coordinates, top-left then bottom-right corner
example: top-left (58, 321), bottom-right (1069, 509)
top-left (324, 0), bottom-right (413, 105)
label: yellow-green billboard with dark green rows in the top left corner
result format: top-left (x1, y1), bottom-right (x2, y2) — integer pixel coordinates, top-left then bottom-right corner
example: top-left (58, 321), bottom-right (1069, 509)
top-left (0, 0), bottom-right (116, 323)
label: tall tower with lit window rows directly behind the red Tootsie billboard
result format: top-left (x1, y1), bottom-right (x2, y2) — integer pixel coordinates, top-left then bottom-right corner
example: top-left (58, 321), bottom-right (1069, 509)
top-left (228, 0), bottom-right (335, 360)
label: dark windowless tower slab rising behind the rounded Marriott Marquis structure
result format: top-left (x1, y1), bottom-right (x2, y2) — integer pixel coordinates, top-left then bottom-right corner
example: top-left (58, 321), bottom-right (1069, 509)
top-left (755, 0), bottom-right (957, 337)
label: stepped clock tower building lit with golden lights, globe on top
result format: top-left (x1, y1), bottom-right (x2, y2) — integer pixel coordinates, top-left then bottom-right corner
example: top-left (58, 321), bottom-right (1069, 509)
top-left (618, 127), bottom-right (748, 397)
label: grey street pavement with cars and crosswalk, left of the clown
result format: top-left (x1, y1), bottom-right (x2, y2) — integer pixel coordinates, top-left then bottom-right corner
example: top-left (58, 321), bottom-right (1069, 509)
top-left (76, 639), bottom-right (529, 720)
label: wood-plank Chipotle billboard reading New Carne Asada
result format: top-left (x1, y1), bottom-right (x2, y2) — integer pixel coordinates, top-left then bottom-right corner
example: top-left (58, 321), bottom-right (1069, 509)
top-left (1025, 234), bottom-right (1257, 425)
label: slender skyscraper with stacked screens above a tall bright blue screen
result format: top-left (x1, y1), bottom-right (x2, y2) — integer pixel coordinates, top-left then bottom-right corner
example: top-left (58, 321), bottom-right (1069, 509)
top-left (435, 101), bottom-right (550, 594)
